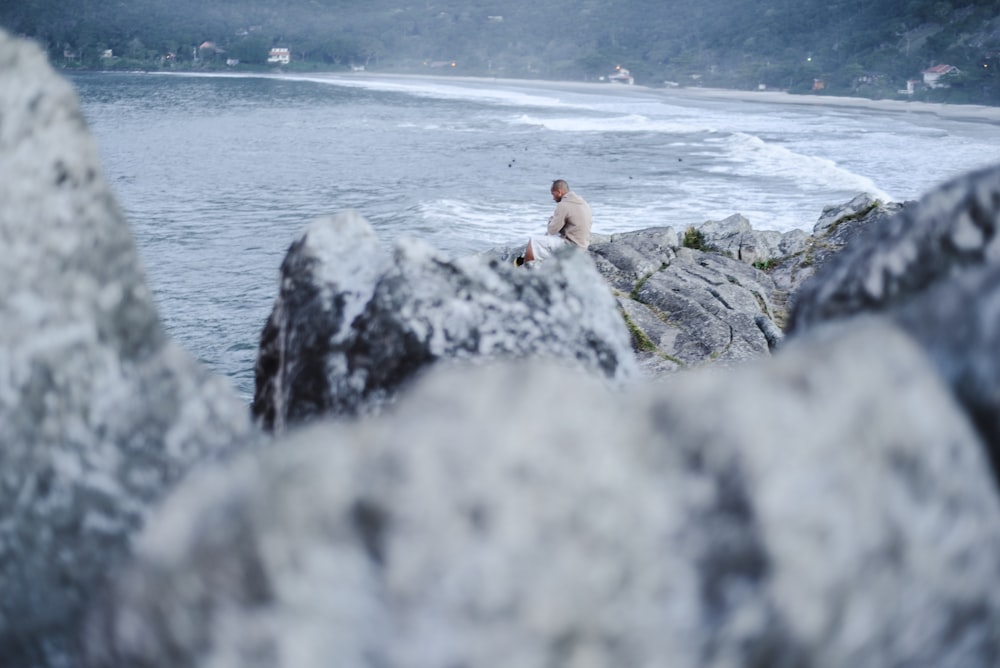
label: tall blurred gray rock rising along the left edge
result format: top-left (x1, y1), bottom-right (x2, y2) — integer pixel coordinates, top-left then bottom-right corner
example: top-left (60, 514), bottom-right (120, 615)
top-left (0, 31), bottom-right (249, 668)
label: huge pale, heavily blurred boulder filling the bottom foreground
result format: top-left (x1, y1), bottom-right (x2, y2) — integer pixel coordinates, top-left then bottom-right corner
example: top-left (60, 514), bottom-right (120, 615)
top-left (87, 321), bottom-right (1000, 668)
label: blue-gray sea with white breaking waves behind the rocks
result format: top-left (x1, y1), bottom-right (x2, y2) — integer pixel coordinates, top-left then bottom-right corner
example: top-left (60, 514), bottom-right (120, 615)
top-left (71, 73), bottom-right (1000, 400)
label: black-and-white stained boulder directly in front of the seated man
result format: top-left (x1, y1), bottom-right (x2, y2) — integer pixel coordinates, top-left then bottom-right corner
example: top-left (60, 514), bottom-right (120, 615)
top-left (254, 213), bottom-right (636, 431)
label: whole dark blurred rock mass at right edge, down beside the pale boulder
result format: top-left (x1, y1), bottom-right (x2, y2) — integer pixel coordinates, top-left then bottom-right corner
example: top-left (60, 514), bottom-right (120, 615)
top-left (790, 166), bottom-right (1000, 481)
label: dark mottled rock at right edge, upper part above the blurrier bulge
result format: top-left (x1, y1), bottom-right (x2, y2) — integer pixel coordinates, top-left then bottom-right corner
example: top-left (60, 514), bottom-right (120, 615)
top-left (789, 166), bottom-right (1000, 332)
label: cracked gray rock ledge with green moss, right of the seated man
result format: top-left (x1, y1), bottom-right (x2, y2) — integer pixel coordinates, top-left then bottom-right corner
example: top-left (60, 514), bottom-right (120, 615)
top-left (590, 194), bottom-right (902, 377)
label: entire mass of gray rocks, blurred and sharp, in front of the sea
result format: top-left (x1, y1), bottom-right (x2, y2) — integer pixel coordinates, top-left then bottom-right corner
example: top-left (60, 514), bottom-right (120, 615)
top-left (0, 31), bottom-right (1000, 668)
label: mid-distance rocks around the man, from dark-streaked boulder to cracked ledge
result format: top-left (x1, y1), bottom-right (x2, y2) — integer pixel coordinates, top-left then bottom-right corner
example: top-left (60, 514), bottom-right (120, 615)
top-left (253, 194), bottom-right (902, 431)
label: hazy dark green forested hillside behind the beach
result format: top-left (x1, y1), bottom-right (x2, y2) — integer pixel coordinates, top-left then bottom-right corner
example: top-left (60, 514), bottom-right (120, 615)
top-left (0, 0), bottom-right (1000, 104)
